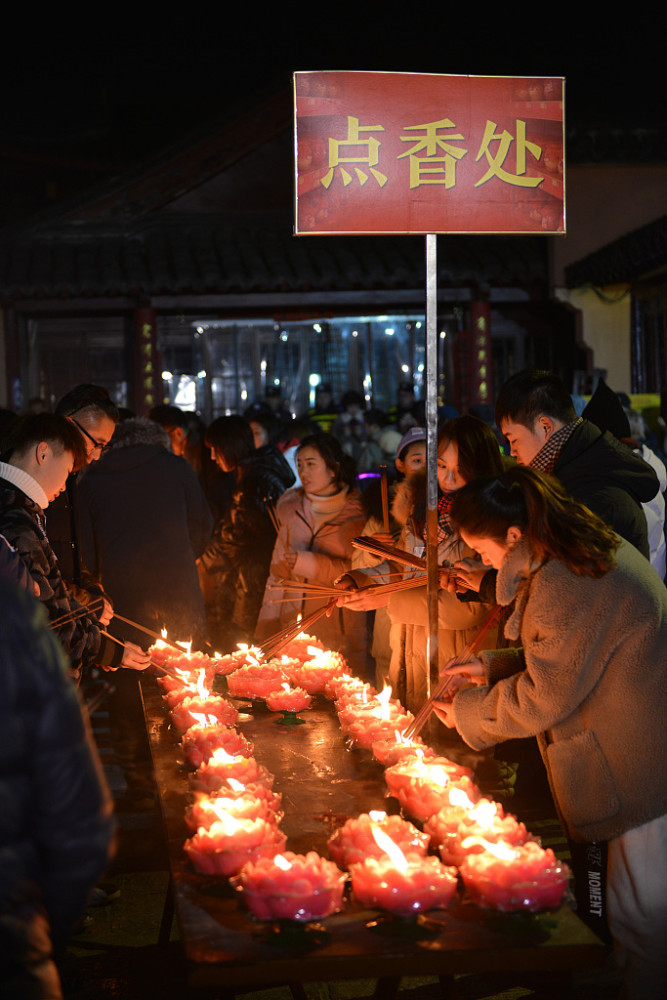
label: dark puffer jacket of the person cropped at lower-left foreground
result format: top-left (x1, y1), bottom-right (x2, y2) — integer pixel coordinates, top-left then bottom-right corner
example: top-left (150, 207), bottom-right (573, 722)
top-left (0, 580), bottom-right (113, 980)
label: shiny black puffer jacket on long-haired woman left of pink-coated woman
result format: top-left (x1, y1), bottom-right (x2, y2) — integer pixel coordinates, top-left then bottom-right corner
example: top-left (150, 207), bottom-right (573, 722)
top-left (201, 445), bottom-right (294, 641)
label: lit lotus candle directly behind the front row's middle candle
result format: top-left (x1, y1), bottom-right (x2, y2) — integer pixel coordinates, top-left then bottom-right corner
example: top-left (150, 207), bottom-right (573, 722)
top-left (328, 811), bottom-right (429, 868)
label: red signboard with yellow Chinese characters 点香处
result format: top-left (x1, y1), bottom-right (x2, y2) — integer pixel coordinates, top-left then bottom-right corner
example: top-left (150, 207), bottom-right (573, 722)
top-left (294, 72), bottom-right (565, 235)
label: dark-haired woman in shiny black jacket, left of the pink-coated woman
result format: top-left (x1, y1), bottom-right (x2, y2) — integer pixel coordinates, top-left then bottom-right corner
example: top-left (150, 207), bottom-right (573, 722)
top-left (200, 414), bottom-right (294, 651)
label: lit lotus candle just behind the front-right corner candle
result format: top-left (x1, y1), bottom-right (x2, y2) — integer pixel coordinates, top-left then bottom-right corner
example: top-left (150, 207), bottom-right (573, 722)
top-left (424, 789), bottom-right (534, 865)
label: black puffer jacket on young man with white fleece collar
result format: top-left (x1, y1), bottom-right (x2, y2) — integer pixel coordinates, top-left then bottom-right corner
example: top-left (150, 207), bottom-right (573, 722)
top-left (0, 470), bottom-right (122, 678)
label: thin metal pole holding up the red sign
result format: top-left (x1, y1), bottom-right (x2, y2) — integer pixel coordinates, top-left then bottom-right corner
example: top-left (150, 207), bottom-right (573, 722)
top-left (426, 233), bottom-right (438, 697)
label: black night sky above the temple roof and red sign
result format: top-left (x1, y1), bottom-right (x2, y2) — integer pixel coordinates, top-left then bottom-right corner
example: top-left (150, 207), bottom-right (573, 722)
top-left (0, 6), bottom-right (665, 220)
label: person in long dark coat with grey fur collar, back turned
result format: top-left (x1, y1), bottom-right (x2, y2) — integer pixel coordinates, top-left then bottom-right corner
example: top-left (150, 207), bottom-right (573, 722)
top-left (77, 417), bottom-right (213, 811)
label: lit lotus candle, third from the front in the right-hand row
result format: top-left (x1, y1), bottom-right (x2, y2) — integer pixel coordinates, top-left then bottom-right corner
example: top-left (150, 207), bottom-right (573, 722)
top-left (385, 757), bottom-right (481, 822)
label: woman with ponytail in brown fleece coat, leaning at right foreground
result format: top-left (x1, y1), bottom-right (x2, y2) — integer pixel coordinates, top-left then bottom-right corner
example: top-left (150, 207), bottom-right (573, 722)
top-left (438, 467), bottom-right (667, 1000)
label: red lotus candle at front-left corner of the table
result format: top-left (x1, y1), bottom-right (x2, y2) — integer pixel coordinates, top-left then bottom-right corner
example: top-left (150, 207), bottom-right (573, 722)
top-left (235, 851), bottom-right (346, 921)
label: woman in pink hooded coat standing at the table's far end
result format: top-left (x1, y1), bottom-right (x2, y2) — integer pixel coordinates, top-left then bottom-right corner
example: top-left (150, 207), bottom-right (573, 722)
top-left (256, 434), bottom-right (367, 672)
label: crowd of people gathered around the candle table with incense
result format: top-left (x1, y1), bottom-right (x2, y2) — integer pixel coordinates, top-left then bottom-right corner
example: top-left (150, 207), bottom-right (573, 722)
top-left (0, 370), bottom-right (667, 1000)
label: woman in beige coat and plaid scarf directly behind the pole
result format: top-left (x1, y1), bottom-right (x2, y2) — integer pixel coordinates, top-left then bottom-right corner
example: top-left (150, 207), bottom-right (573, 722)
top-left (341, 415), bottom-right (502, 711)
